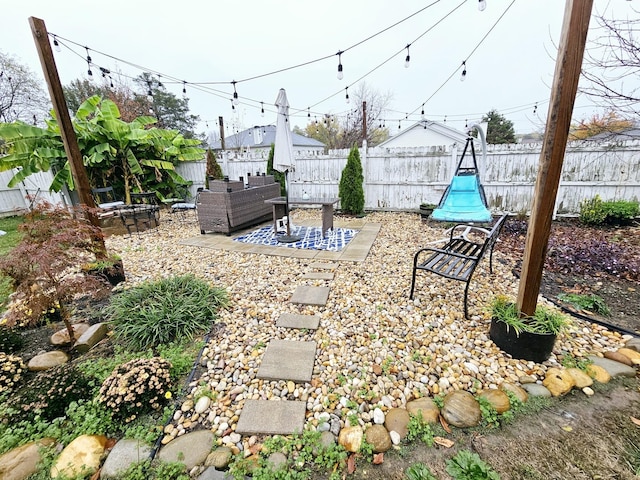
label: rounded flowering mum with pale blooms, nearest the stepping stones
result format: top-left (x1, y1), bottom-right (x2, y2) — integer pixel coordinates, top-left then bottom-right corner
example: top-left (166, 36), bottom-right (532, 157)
top-left (98, 357), bottom-right (171, 422)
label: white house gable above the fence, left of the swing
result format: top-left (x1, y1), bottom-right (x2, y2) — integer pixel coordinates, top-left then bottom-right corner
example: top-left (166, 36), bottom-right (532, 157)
top-left (377, 120), bottom-right (467, 148)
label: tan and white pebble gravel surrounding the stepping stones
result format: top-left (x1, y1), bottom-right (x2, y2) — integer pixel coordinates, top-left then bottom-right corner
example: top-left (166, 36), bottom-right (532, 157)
top-left (107, 210), bottom-right (623, 443)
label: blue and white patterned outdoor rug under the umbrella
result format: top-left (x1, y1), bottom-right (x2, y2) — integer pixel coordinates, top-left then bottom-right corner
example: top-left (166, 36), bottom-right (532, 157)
top-left (233, 225), bottom-right (358, 252)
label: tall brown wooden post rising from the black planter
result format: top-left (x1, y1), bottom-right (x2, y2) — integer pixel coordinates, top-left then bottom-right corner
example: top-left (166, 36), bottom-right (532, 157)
top-left (517, 0), bottom-right (593, 315)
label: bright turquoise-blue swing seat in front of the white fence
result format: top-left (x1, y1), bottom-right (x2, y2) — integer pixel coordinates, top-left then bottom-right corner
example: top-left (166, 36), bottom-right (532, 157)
top-left (431, 173), bottom-right (491, 222)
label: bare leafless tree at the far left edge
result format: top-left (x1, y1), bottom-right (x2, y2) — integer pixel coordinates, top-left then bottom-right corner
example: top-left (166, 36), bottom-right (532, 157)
top-left (0, 52), bottom-right (51, 123)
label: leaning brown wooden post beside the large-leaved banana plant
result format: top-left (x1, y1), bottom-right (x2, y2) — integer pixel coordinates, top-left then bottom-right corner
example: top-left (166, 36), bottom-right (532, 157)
top-left (29, 17), bottom-right (100, 226)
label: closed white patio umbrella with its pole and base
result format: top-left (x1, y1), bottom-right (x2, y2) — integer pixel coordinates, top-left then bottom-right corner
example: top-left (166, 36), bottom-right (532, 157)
top-left (273, 88), bottom-right (300, 242)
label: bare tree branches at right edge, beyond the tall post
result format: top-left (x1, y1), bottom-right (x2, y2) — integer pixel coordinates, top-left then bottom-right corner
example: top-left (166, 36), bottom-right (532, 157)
top-left (580, 10), bottom-right (640, 116)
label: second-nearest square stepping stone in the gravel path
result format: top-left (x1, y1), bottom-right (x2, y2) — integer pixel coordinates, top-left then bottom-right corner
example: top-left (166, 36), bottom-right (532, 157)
top-left (258, 340), bottom-right (316, 382)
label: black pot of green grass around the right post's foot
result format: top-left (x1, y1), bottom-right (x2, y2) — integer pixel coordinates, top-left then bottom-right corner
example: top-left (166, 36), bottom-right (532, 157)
top-left (489, 295), bottom-right (567, 363)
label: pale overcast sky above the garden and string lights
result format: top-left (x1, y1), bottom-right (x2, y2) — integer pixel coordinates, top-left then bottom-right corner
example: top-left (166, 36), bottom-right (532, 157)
top-left (0, 0), bottom-right (633, 134)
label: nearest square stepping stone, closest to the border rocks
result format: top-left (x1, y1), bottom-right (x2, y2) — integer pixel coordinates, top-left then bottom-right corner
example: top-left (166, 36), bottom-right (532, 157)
top-left (236, 400), bottom-right (307, 435)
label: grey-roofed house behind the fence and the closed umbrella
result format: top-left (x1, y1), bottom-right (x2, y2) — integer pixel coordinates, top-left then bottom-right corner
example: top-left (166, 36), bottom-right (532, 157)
top-left (211, 125), bottom-right (325, 156)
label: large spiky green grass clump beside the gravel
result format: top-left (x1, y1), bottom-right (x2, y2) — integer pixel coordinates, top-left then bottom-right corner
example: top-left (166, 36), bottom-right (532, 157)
top-left (106, 274), bottom-right (227, 351)
